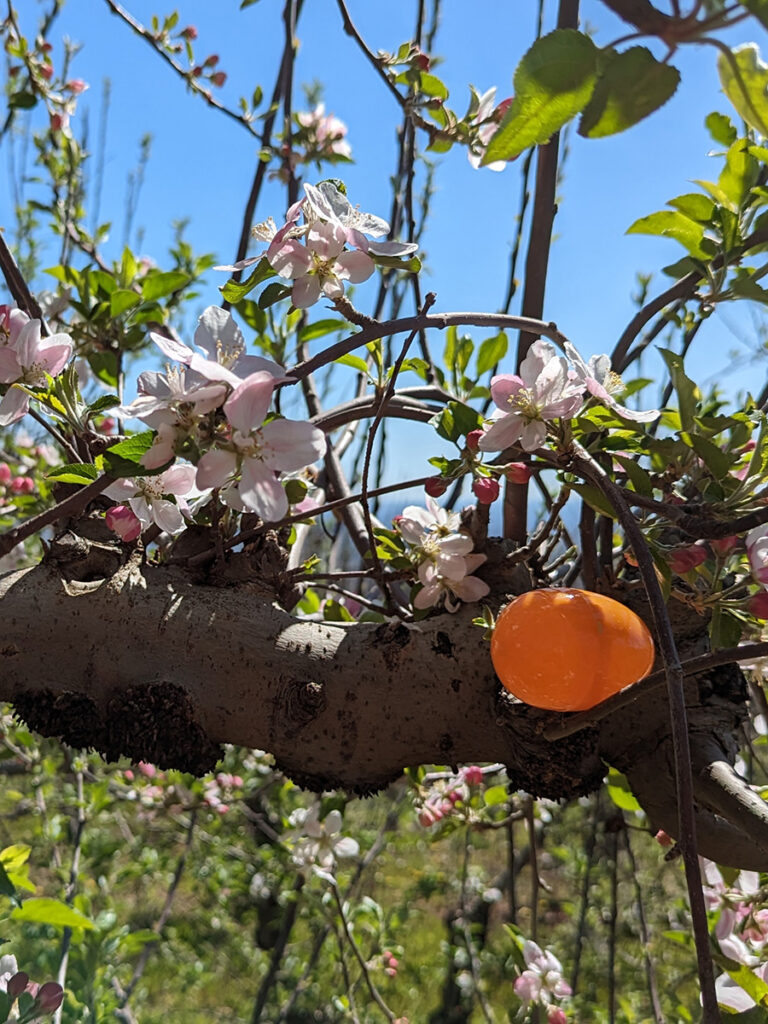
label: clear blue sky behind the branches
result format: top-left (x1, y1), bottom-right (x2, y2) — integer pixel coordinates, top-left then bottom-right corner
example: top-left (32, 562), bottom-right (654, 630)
top-left (0, 0), bottom-right (768, 501)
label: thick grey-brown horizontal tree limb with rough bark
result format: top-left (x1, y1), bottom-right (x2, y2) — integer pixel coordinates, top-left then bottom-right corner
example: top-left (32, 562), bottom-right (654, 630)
top-left (0, 558), bottom-right (768, 869)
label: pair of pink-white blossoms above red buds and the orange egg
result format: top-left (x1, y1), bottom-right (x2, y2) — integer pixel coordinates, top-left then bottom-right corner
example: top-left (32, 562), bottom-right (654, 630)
top-left (478, 341), bottom-right (659, 452)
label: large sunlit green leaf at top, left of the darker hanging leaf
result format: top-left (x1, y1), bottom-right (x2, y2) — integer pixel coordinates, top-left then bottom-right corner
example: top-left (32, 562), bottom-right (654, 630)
top-left (482, 29), bottom-right (598, 164)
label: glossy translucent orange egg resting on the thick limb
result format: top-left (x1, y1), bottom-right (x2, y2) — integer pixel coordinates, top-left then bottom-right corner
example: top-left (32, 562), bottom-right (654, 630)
top-left (490, 588), bottom-right (654, 711)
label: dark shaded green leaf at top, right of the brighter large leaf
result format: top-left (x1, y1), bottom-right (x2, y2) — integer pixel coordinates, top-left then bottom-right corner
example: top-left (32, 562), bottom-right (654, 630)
top-left (579, 46), bottom-right (680, 138)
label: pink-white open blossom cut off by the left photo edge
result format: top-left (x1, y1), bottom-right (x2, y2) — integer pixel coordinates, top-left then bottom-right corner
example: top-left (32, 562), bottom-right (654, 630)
top-left (0, 306), bottom-right (73, 427)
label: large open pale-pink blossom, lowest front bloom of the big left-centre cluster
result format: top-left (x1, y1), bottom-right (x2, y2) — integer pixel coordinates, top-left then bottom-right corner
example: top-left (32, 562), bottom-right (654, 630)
top-left (198, 371), bottom-right (326, 522)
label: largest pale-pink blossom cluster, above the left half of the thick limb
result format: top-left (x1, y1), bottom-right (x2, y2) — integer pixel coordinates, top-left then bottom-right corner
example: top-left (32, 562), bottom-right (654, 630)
top-left (115, 306), bottom-right (326, 540)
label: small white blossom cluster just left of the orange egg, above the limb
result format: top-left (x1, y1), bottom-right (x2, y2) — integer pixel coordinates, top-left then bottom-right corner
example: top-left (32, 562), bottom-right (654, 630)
top-left (394, 496), bottom-right (489, 611)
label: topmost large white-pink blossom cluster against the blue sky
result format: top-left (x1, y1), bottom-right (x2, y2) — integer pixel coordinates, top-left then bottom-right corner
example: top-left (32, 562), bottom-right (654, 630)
top-left (218, 181), bottom-right (418, 309)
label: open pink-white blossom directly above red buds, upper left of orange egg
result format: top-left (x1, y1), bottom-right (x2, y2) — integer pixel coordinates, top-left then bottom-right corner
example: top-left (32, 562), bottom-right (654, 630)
top-left (478, 341), bottom-right (584, 452)
